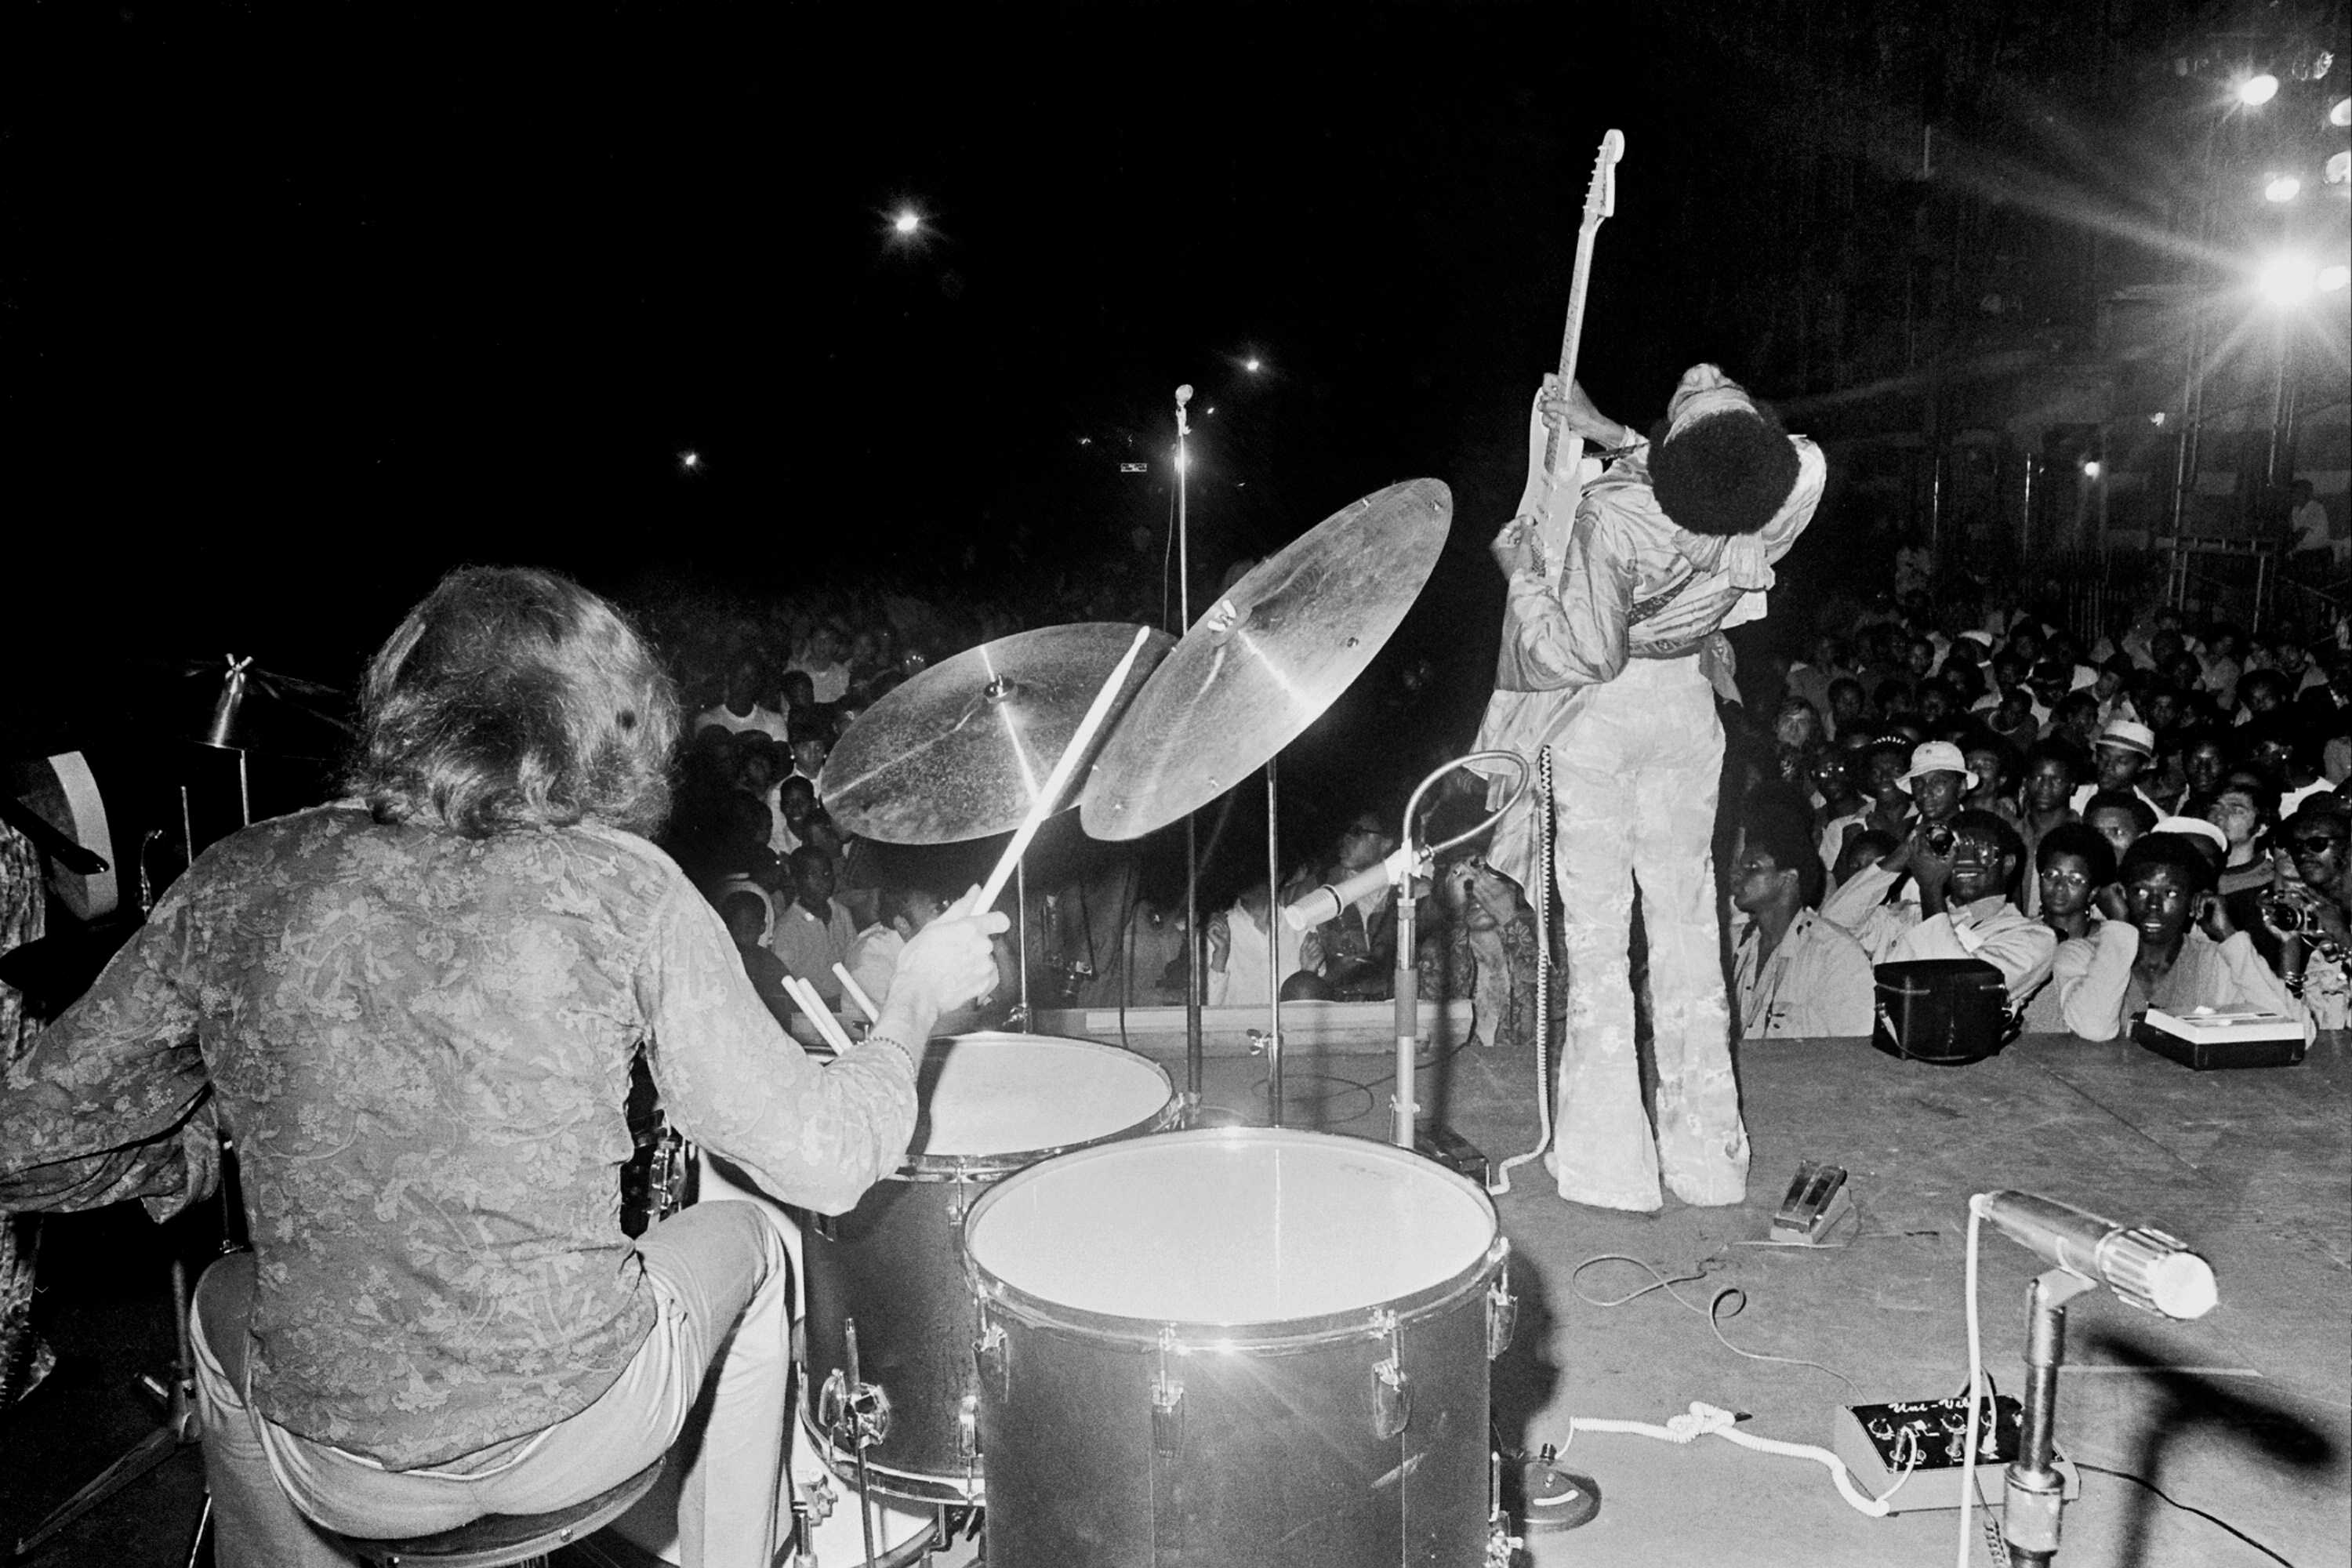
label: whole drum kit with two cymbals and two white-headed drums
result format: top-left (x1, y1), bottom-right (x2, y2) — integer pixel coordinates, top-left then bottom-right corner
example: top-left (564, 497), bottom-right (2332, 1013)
top-left (619, 480), bottom-right (1512, 1568)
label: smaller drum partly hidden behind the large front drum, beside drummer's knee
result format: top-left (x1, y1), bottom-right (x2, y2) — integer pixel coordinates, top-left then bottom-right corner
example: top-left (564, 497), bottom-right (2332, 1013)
top-left (802, 1034), bottom-right (1181, 1502)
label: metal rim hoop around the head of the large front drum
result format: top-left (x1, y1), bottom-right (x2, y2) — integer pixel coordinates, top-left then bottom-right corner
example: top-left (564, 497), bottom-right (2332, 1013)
top-left (964, 1126), bottom-right (1510, 1354)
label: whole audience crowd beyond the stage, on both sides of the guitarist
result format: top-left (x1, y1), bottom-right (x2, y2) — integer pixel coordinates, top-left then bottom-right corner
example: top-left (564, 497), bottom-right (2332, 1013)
top-left (635, 545), bottom-right (2352, 1062)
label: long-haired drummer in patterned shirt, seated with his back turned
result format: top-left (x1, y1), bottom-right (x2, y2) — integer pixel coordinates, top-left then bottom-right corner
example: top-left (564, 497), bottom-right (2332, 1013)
top-left (0, 569), bottom-right (1002, 1568)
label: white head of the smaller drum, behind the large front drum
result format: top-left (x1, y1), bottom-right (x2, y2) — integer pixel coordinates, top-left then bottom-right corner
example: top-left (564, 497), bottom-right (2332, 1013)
top-left (908, 1034), bottom-right (1176, 1159)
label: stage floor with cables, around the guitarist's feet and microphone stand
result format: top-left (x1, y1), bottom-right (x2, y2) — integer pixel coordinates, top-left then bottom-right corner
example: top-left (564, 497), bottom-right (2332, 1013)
top-left (0, 1036), bottom-right (2352, 1568)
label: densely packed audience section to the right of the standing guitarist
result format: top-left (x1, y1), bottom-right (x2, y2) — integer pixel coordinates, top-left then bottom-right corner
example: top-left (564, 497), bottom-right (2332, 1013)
top-left (1726, 593), bottom-right (2352, 1039)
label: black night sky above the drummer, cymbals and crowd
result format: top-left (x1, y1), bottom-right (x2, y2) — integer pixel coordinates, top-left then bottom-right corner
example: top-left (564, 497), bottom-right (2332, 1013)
top-left (0, 0), bottom-right (2239, 742)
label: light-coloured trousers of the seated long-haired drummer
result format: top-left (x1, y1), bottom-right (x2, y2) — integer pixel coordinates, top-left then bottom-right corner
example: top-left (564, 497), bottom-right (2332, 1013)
top-left (191, 1203), bottom-right (793, 1568)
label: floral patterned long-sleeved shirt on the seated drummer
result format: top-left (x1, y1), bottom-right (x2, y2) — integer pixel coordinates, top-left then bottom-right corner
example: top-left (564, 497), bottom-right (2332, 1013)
top-left (0, 801), bottom-right (920, 1469)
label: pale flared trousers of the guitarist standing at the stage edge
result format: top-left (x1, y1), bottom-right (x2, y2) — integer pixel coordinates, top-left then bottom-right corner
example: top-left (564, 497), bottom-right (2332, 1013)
top-left (1552, 659), bottom-right (1748, 1210)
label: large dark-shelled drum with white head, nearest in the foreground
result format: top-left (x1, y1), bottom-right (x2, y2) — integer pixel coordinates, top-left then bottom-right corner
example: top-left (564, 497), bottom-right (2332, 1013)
top-left (964, 1128), bottom-right (1512, 1568)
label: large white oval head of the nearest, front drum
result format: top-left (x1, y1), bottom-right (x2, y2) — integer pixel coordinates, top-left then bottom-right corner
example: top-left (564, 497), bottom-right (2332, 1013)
top-left (964, 1128), bottom-right (1496, 1323)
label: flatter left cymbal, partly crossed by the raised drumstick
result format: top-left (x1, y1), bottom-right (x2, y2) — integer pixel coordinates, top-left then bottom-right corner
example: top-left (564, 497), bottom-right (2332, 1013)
top-left (818, 623), bottom-right (1176, 844)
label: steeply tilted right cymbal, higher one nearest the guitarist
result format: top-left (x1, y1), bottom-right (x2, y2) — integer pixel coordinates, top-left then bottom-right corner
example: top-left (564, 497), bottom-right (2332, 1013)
top-left (1077, 480), bottom-right (1454, 839)
